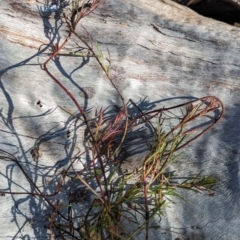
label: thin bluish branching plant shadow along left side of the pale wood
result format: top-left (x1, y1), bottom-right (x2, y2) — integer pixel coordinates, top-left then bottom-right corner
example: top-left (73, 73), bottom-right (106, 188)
top-left (0, 0), bottom-right (88, 239)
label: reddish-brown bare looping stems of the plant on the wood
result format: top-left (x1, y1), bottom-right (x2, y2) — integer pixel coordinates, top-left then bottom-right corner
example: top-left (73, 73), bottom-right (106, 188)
top-left (0, 0), bottom-right (224, 239)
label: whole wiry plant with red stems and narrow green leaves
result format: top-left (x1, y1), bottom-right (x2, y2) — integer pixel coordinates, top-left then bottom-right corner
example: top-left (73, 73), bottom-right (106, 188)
top-left (0, 0), bottom-right (223, 240)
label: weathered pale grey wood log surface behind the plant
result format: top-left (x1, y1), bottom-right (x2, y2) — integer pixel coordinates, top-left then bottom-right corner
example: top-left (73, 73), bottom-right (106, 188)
top-left (0, 0), bottom-right (240, 240)
